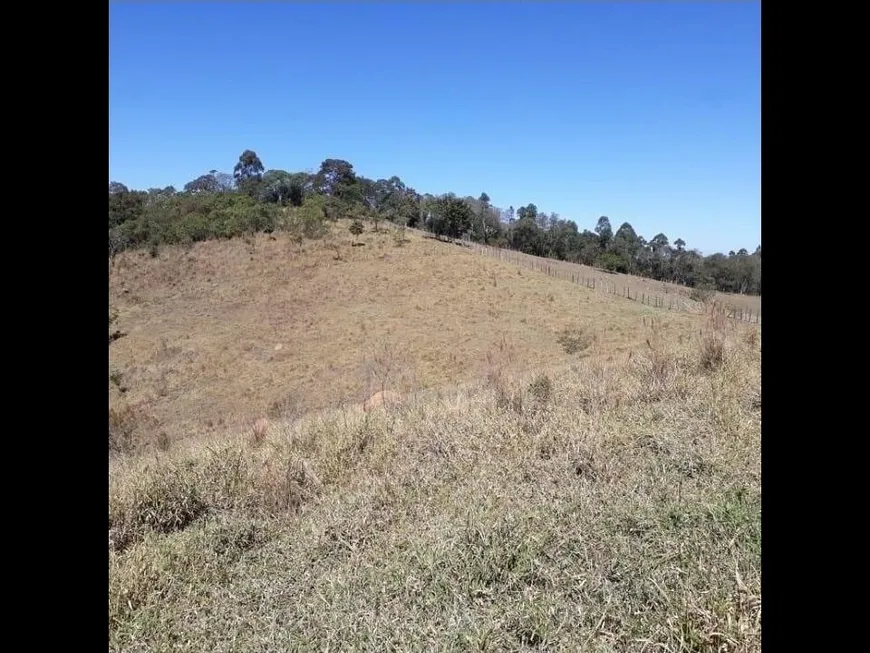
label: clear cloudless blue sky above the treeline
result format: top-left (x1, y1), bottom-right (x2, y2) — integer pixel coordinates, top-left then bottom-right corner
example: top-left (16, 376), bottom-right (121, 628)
top-left (109, 1), bottom-right (761, 254)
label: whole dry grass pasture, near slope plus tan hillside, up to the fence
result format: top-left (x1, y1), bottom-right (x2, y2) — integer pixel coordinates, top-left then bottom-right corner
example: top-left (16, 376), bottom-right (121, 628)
top-left (108, 220), bottom-right (761, 653)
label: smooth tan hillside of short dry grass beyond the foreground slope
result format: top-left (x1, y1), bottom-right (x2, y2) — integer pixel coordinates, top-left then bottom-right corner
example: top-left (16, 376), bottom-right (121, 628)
top-left (109, 223), bottom-right (724, 448)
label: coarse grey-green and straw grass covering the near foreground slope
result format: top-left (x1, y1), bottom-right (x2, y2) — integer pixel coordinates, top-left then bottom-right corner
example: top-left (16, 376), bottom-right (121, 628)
top-left (109, 324), bottom-right (761, 652)
